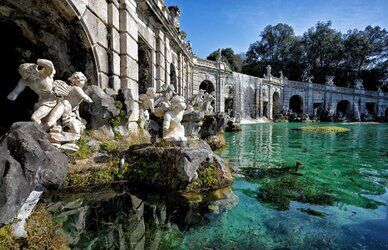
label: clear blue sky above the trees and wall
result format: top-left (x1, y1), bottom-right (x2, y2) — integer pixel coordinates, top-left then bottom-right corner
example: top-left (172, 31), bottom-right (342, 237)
top-left (166, 0), bottom-right (388, 57)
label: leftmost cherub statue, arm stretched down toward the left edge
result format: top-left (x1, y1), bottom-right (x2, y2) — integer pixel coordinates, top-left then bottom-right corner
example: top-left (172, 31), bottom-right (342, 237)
top-left (7, 59), bottom-right (57, 124)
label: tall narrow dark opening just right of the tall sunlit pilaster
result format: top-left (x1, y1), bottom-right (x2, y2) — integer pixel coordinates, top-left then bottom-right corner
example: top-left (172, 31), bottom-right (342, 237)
top-left (138, 38), bottom-right (152, 94)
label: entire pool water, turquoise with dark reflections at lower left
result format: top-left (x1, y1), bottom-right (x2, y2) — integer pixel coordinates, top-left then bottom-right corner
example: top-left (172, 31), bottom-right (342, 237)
top-left (51, 124), bottom-right (388, 249)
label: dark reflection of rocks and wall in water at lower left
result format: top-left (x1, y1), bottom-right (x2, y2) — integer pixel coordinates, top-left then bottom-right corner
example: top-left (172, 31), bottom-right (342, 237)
top-left (45, 186), bottom-right (238, 249)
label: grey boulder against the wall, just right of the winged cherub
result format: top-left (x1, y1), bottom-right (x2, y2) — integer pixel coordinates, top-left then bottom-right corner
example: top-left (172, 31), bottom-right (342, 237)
top-left (82, 85), bottom-right (120, 129)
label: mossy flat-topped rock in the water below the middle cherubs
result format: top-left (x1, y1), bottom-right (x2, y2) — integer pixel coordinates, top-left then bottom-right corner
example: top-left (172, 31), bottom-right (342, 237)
top-left (126, 140), bottom-right (232, 191)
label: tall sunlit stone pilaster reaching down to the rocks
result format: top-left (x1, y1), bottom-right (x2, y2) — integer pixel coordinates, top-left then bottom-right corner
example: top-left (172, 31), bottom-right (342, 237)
top-left (120, 0), bottom-right (139, 131)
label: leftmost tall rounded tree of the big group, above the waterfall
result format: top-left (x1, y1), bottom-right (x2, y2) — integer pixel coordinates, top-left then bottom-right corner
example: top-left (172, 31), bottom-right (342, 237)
top-left (243, 23), bottom-right (304, 80)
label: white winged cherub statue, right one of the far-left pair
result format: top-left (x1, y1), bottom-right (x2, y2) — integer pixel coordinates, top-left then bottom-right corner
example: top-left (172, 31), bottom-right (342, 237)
top-left (47, 72), bottom-right (93, 134)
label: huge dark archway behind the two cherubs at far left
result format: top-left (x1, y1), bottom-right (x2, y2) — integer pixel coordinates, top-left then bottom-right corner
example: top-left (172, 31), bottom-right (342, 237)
top-left (0, 0), bottom-right (98, 134)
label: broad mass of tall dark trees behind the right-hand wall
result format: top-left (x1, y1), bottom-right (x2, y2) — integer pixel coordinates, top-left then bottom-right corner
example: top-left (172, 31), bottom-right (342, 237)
top-left (242, 21), bottom-right (388, 89)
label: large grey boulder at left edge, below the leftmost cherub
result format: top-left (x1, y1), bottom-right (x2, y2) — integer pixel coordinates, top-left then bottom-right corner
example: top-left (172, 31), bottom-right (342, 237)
top-left (0, 122), bottom-right (67, 224)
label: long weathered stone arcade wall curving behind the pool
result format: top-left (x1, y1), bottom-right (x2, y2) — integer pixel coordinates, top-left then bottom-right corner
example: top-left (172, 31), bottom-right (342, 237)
top-left (0, 0), bottom-right (388, 129)
